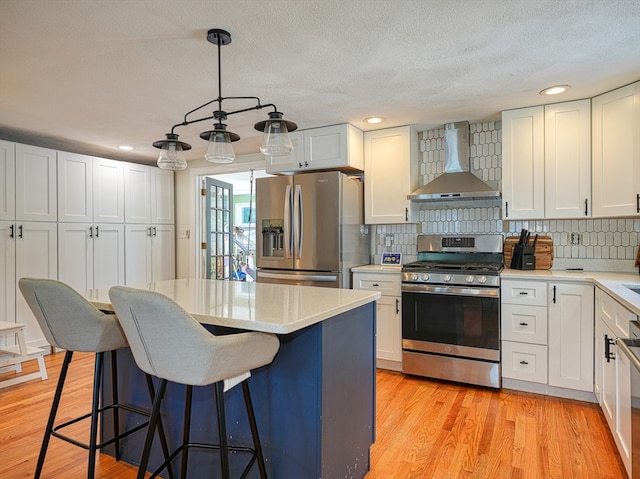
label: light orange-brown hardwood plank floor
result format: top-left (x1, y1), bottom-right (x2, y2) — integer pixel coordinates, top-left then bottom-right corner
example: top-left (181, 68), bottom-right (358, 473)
top-left (0, 353), bottom-right (626, 479)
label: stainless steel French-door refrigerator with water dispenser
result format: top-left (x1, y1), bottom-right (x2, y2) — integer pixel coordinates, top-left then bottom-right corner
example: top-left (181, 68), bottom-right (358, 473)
top-left (256, 171), bottom-right (370, 288)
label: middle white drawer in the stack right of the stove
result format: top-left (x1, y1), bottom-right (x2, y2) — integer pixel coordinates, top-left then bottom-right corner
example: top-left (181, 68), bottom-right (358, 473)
top-left (501, 304), bottom-right (547, 345)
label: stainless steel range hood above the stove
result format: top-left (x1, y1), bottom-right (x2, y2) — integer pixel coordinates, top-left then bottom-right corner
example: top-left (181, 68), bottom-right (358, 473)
top-left (407, 121), bottom-right (500, 201)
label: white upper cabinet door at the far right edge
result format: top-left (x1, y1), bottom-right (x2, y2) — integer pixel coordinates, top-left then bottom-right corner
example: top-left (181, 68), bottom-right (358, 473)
top-left (591, 82), bottom-right (640, 217)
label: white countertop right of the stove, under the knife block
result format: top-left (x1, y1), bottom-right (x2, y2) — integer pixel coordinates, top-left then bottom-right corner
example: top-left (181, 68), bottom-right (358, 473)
top-left (500, 268), bottom-right (640, 316)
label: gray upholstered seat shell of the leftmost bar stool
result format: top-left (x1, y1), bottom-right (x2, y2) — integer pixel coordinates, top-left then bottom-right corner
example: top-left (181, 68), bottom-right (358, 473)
top-left (18, 278), bottom-right (127, 352)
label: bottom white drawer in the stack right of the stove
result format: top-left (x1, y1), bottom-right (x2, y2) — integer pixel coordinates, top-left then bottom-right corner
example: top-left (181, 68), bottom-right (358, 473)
top-left (502, 341), bottom-right (547, 384)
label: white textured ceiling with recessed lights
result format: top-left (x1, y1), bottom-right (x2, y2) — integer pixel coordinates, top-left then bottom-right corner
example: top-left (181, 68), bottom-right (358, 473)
top-left (0, 0), bottom-right (640, 167)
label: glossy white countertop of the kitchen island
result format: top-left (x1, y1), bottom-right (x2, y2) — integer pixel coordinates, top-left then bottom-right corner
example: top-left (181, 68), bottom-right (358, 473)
top-left (81, 278), bottom-right (381, 334)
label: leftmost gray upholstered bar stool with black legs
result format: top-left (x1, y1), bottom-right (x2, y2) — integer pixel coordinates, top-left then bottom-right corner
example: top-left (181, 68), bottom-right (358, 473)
top-left (18, 278), bottom-right (173, 479)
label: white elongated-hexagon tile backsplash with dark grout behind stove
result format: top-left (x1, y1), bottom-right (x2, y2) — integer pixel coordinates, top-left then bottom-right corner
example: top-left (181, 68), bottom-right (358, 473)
top-left (373, 122), bottom-right (640, 271)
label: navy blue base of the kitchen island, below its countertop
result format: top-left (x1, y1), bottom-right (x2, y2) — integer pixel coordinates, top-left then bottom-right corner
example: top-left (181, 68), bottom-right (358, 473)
top-left (102, 302), bottom-right (375, 479)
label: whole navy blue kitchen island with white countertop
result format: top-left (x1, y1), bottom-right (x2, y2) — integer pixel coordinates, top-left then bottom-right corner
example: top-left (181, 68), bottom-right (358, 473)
top-left (84, 279), bottom-right (380, 479)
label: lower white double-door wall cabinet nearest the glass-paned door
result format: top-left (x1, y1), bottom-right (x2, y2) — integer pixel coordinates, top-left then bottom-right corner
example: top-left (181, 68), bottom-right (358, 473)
top-left (125, 224), bottom-right (175, 285)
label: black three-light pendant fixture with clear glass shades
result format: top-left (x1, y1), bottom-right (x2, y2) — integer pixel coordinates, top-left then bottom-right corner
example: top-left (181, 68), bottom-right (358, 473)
top-left (153, 28), bottom-right (298, 170)
